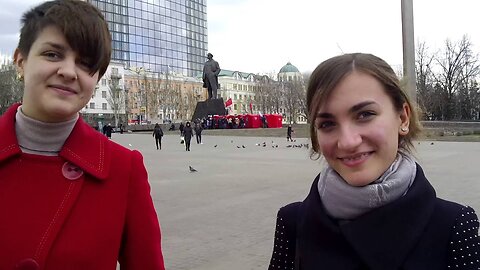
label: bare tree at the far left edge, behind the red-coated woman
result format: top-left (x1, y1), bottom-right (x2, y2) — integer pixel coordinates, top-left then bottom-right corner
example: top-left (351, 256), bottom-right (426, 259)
top-left (0, 63), bottom-right (24, 115)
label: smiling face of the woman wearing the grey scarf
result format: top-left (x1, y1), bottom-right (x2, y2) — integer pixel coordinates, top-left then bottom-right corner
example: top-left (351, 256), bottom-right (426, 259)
top-left (315, 71), bottom-right (410, 186)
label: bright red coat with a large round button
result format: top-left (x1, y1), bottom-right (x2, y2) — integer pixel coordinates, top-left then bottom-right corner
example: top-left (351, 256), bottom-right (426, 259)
top-left (0, 104), bottom-right (164, 270)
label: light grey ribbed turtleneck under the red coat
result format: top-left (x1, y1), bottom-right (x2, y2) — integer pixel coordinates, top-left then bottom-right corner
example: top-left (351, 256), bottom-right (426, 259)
top-left (15, 106), bottom-right (78, 156)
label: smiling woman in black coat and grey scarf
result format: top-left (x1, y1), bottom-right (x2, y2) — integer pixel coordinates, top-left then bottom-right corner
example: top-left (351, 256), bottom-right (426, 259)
top-left (269, 53), bottom-right (480, 270)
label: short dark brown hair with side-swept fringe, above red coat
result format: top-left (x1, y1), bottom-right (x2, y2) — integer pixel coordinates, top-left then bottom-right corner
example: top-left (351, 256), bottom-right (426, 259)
top-left (18, 0), bottom-right (112, 78)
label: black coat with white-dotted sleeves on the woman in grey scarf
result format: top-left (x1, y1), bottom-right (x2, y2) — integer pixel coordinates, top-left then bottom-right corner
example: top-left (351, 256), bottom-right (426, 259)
top-left (269, 165), bottom-right (480, 270)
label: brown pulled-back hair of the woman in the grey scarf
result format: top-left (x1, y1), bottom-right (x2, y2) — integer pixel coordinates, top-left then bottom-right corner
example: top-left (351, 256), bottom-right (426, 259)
top-left (307, 53), bottom-right (421, 156)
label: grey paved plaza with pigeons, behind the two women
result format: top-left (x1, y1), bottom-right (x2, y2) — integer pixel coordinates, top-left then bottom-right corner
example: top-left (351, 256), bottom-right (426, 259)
top-left (112, 133), bottom-right (480, 270)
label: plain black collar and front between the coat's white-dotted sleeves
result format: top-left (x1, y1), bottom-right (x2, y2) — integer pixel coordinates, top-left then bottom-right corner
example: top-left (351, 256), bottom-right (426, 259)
top-left (297, 164), bottom-right (436, 269)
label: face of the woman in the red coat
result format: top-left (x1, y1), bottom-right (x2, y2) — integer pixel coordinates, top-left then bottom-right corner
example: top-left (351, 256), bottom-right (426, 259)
top-left (15, 26), bottom-right (99, 122)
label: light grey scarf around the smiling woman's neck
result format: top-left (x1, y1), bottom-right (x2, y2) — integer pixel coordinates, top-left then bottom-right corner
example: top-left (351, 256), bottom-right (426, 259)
top-left (318, 153), bottom-right (417, 220)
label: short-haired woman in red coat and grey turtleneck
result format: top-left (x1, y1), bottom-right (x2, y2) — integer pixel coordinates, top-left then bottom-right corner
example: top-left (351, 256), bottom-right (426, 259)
top-left (0, 0), bottom-right (164, 270)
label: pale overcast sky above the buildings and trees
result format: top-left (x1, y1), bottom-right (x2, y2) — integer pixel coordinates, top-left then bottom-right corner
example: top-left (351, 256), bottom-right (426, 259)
top-left (0, 0), bottom-right (480, 73)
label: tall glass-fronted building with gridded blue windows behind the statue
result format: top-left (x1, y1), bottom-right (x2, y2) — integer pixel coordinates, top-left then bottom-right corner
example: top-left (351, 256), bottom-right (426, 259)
top-left (87, 0), bottom-right (208, 77)
